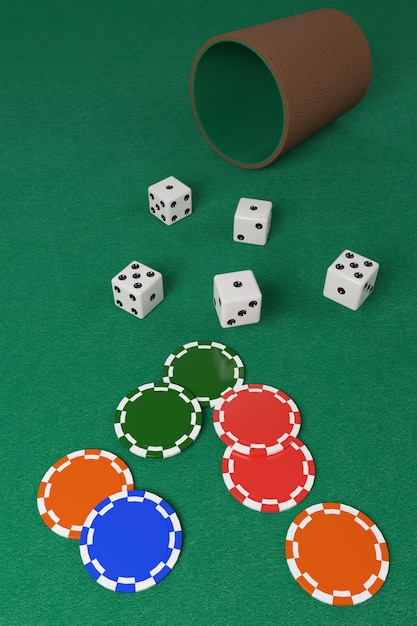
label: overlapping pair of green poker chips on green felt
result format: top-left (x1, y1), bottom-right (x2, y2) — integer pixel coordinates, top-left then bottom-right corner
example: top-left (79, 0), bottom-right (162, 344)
top-left (114, 341), bottom-right (244, 458)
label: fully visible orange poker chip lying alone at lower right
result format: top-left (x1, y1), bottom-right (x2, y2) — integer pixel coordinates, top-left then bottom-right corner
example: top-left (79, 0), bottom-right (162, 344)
top-left (285, 502), bottom-right (389, 605)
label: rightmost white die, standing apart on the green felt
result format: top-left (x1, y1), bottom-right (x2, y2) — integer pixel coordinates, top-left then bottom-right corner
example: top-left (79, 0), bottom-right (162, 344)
top-left (323, 250), bottom-right (379, 311)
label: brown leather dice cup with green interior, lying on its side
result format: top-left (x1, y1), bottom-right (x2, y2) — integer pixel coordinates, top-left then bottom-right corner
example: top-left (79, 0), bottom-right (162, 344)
top-left (190, 9), bottom-right (372, 169)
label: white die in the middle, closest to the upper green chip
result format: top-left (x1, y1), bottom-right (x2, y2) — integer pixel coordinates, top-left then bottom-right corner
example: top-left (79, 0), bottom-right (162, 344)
top-left (214, 270), bottom-right (262, 328)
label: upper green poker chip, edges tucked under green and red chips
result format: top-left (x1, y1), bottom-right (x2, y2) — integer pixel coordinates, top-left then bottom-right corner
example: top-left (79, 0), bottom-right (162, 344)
top-left (163, 341), bottom-right (245, 407)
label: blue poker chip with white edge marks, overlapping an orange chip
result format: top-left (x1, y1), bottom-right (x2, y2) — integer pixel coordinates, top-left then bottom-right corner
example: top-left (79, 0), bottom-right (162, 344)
top-left (80, 490), bottom-right (182, 593)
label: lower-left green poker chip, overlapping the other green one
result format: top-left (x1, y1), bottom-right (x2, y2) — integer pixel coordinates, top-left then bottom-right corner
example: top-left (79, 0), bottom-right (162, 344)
top-left (114, 382), bottom-right (202, 458)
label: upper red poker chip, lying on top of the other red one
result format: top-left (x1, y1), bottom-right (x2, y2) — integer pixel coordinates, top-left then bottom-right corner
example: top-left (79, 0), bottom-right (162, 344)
top-left (213, 384), bottom-right (301, 455)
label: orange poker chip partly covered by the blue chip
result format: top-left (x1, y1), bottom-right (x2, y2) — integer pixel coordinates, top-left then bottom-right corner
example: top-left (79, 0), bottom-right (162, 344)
top-left (37, 449), bottom-right (134, 539)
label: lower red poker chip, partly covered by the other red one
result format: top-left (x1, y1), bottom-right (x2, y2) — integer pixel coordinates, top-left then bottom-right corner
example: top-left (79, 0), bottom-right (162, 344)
top-left (222, 438), bottom-right (315, 513)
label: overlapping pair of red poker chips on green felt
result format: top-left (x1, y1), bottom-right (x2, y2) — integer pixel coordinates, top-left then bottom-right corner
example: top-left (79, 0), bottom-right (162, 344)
top-left (213, 384), bottom-right (315, 512)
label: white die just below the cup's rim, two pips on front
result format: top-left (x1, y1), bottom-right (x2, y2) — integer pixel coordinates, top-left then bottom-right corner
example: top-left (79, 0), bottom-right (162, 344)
top-left (233, 198), bottom-right (272, 246)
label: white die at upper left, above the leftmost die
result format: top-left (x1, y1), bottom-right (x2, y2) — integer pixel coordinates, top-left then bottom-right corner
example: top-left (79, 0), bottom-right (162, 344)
top-left (148, 176), bottom-right (193, 226)
